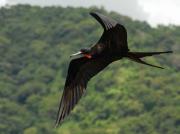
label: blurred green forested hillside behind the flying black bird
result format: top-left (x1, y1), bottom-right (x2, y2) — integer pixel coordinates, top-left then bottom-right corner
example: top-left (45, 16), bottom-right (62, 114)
top-left (0, 5), bottom-right (180, 134)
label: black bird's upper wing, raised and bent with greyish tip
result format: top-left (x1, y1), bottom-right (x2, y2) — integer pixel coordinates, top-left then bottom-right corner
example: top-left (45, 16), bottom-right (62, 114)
top-left (90, 12), bottom-right (129, 52)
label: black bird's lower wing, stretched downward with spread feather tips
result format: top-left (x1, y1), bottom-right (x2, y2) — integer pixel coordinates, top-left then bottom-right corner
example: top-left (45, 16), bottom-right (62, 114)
top-left (55, 57), bottom-right (110, 126)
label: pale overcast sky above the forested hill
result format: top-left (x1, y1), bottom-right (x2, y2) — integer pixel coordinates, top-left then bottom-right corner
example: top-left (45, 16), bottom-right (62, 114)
top-left (0, 0), bottom-right (180, 26)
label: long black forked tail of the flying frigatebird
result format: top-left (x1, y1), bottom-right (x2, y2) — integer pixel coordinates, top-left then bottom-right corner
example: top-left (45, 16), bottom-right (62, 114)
top-left (126, 51), bottom-right (172, 69)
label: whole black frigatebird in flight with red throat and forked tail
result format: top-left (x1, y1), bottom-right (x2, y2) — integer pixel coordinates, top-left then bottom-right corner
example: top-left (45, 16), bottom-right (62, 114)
top-left (56, 12), bottom-right (172, 126)
